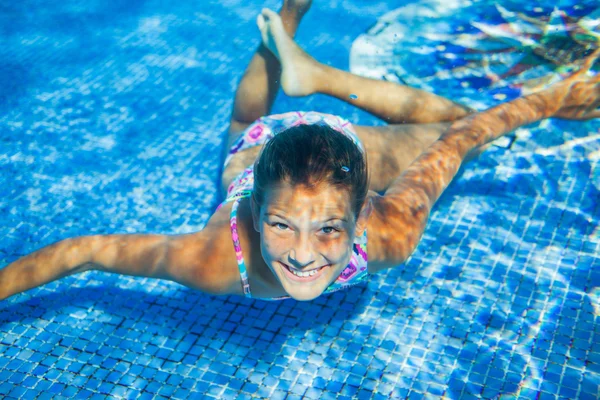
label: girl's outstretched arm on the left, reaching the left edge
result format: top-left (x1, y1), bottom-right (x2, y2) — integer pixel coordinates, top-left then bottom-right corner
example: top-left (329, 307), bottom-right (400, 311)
top-left (0, 216), bottom-right (239, 300)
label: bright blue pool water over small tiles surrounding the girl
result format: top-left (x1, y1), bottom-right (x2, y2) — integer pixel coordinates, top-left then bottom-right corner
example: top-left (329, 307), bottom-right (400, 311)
top-left (0, 0), bottom-right (600, 399)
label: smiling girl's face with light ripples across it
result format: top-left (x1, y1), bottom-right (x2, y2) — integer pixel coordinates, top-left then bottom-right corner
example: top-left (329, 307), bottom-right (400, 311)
top-left (252, 183), bottom-right (368, 300)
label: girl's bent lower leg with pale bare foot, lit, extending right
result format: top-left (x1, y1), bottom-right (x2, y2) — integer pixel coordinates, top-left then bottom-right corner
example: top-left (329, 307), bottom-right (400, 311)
top-left (259, 9), bottom-right (471, 124)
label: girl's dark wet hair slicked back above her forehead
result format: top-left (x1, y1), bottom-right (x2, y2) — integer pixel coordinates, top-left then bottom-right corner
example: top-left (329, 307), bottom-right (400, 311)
top-left (253, 124), bottom-right (369, 218)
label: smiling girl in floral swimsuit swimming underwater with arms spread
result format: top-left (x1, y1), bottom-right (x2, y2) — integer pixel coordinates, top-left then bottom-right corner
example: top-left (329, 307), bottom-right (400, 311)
top-left (0, 0), bottom-right (600, 300)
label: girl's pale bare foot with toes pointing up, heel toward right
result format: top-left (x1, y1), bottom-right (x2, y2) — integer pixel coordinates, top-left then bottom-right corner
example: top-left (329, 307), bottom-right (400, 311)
top-left (256, 8), bottom-right (320, 96)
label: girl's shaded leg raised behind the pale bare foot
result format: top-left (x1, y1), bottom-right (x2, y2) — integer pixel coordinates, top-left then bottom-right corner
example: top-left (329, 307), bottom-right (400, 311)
top-left (226, 0), bottom-right (312, 149)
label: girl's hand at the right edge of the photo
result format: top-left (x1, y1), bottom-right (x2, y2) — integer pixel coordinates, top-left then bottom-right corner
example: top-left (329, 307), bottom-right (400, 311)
top-left (548, 49), bottom-right (600, 121)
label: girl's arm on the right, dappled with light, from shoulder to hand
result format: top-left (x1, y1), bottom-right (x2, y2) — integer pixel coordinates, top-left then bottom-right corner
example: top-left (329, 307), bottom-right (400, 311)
top-left (368, 50), bottom-right (600, 272)
